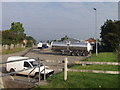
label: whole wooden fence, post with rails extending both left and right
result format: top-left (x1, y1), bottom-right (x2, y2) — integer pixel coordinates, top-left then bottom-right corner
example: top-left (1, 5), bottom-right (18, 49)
top-left (44, 58), bottom-right (120, 81)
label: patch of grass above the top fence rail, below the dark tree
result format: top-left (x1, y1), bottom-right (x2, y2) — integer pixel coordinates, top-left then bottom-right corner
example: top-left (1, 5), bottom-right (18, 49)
top-left (84, 52), bottom-right (118, 62)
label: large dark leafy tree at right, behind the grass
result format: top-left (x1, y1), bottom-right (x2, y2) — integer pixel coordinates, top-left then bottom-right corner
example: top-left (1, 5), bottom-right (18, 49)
top-left (101, 20), bottom-right (120, 52)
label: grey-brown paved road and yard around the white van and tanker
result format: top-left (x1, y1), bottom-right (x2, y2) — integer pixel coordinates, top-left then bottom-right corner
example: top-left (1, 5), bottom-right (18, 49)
top-left (1, 48), bottom-right (85, 88)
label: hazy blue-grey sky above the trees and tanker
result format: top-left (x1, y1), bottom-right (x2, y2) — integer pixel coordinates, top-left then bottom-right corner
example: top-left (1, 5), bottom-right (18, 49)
top-left (2, 2), bottom-right (118, 41)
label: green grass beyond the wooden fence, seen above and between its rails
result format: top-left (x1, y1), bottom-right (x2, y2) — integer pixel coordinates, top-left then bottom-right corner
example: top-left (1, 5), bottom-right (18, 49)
top-left (71, 52), bottom-right (118, 71)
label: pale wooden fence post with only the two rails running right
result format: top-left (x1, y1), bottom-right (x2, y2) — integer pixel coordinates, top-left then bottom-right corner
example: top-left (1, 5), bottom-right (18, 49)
top-left (64, 58), bottom-right (120, 81)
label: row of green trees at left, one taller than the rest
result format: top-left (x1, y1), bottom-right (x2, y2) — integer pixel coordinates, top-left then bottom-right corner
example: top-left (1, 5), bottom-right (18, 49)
top-left (2, 22), bottom-right (36, 47)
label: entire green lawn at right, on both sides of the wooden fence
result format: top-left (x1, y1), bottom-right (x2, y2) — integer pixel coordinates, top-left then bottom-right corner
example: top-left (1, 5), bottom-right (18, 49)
top-left (36, 53), bottom-right (120, 89)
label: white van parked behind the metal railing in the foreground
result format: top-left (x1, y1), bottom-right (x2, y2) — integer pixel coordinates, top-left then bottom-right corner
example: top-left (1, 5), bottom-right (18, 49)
top-left (6, 56), bottom-right (54, 78)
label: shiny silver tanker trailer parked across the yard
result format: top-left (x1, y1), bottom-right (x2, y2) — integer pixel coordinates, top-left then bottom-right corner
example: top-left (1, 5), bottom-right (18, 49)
top-left (52, 41), bottom-right (92, 56)
